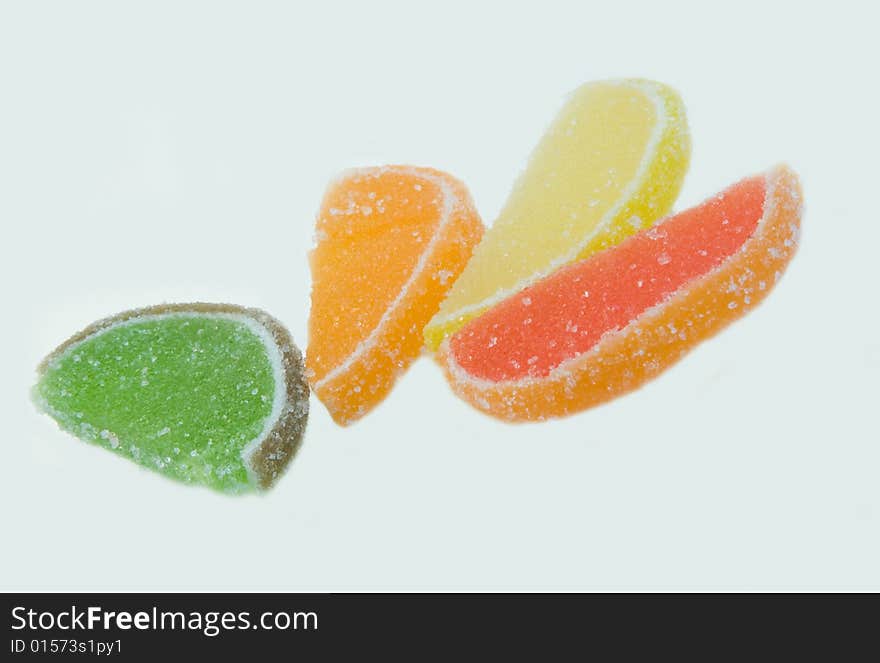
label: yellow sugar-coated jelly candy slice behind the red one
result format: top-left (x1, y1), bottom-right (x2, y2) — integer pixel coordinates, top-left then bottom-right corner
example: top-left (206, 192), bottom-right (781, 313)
top-left (425, 80), bottom-right (690, 350)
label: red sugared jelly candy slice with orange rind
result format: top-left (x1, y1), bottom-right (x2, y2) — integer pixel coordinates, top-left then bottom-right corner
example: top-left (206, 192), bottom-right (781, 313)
top-left (438, 166), bottom-right (801, 421)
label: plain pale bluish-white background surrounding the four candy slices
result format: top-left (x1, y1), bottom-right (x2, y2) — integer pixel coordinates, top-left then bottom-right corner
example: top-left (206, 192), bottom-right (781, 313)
top-left (0, 0), bottom-right (880, 590)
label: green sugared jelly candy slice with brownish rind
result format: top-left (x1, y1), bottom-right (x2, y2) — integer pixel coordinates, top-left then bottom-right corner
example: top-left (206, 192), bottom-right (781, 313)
top-left (33, 304), bottom-right (309, 493)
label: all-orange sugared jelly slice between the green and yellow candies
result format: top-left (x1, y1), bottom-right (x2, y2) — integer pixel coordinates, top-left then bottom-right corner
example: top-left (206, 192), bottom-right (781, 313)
top-left (306, 166), bottom-right (483, 424)
